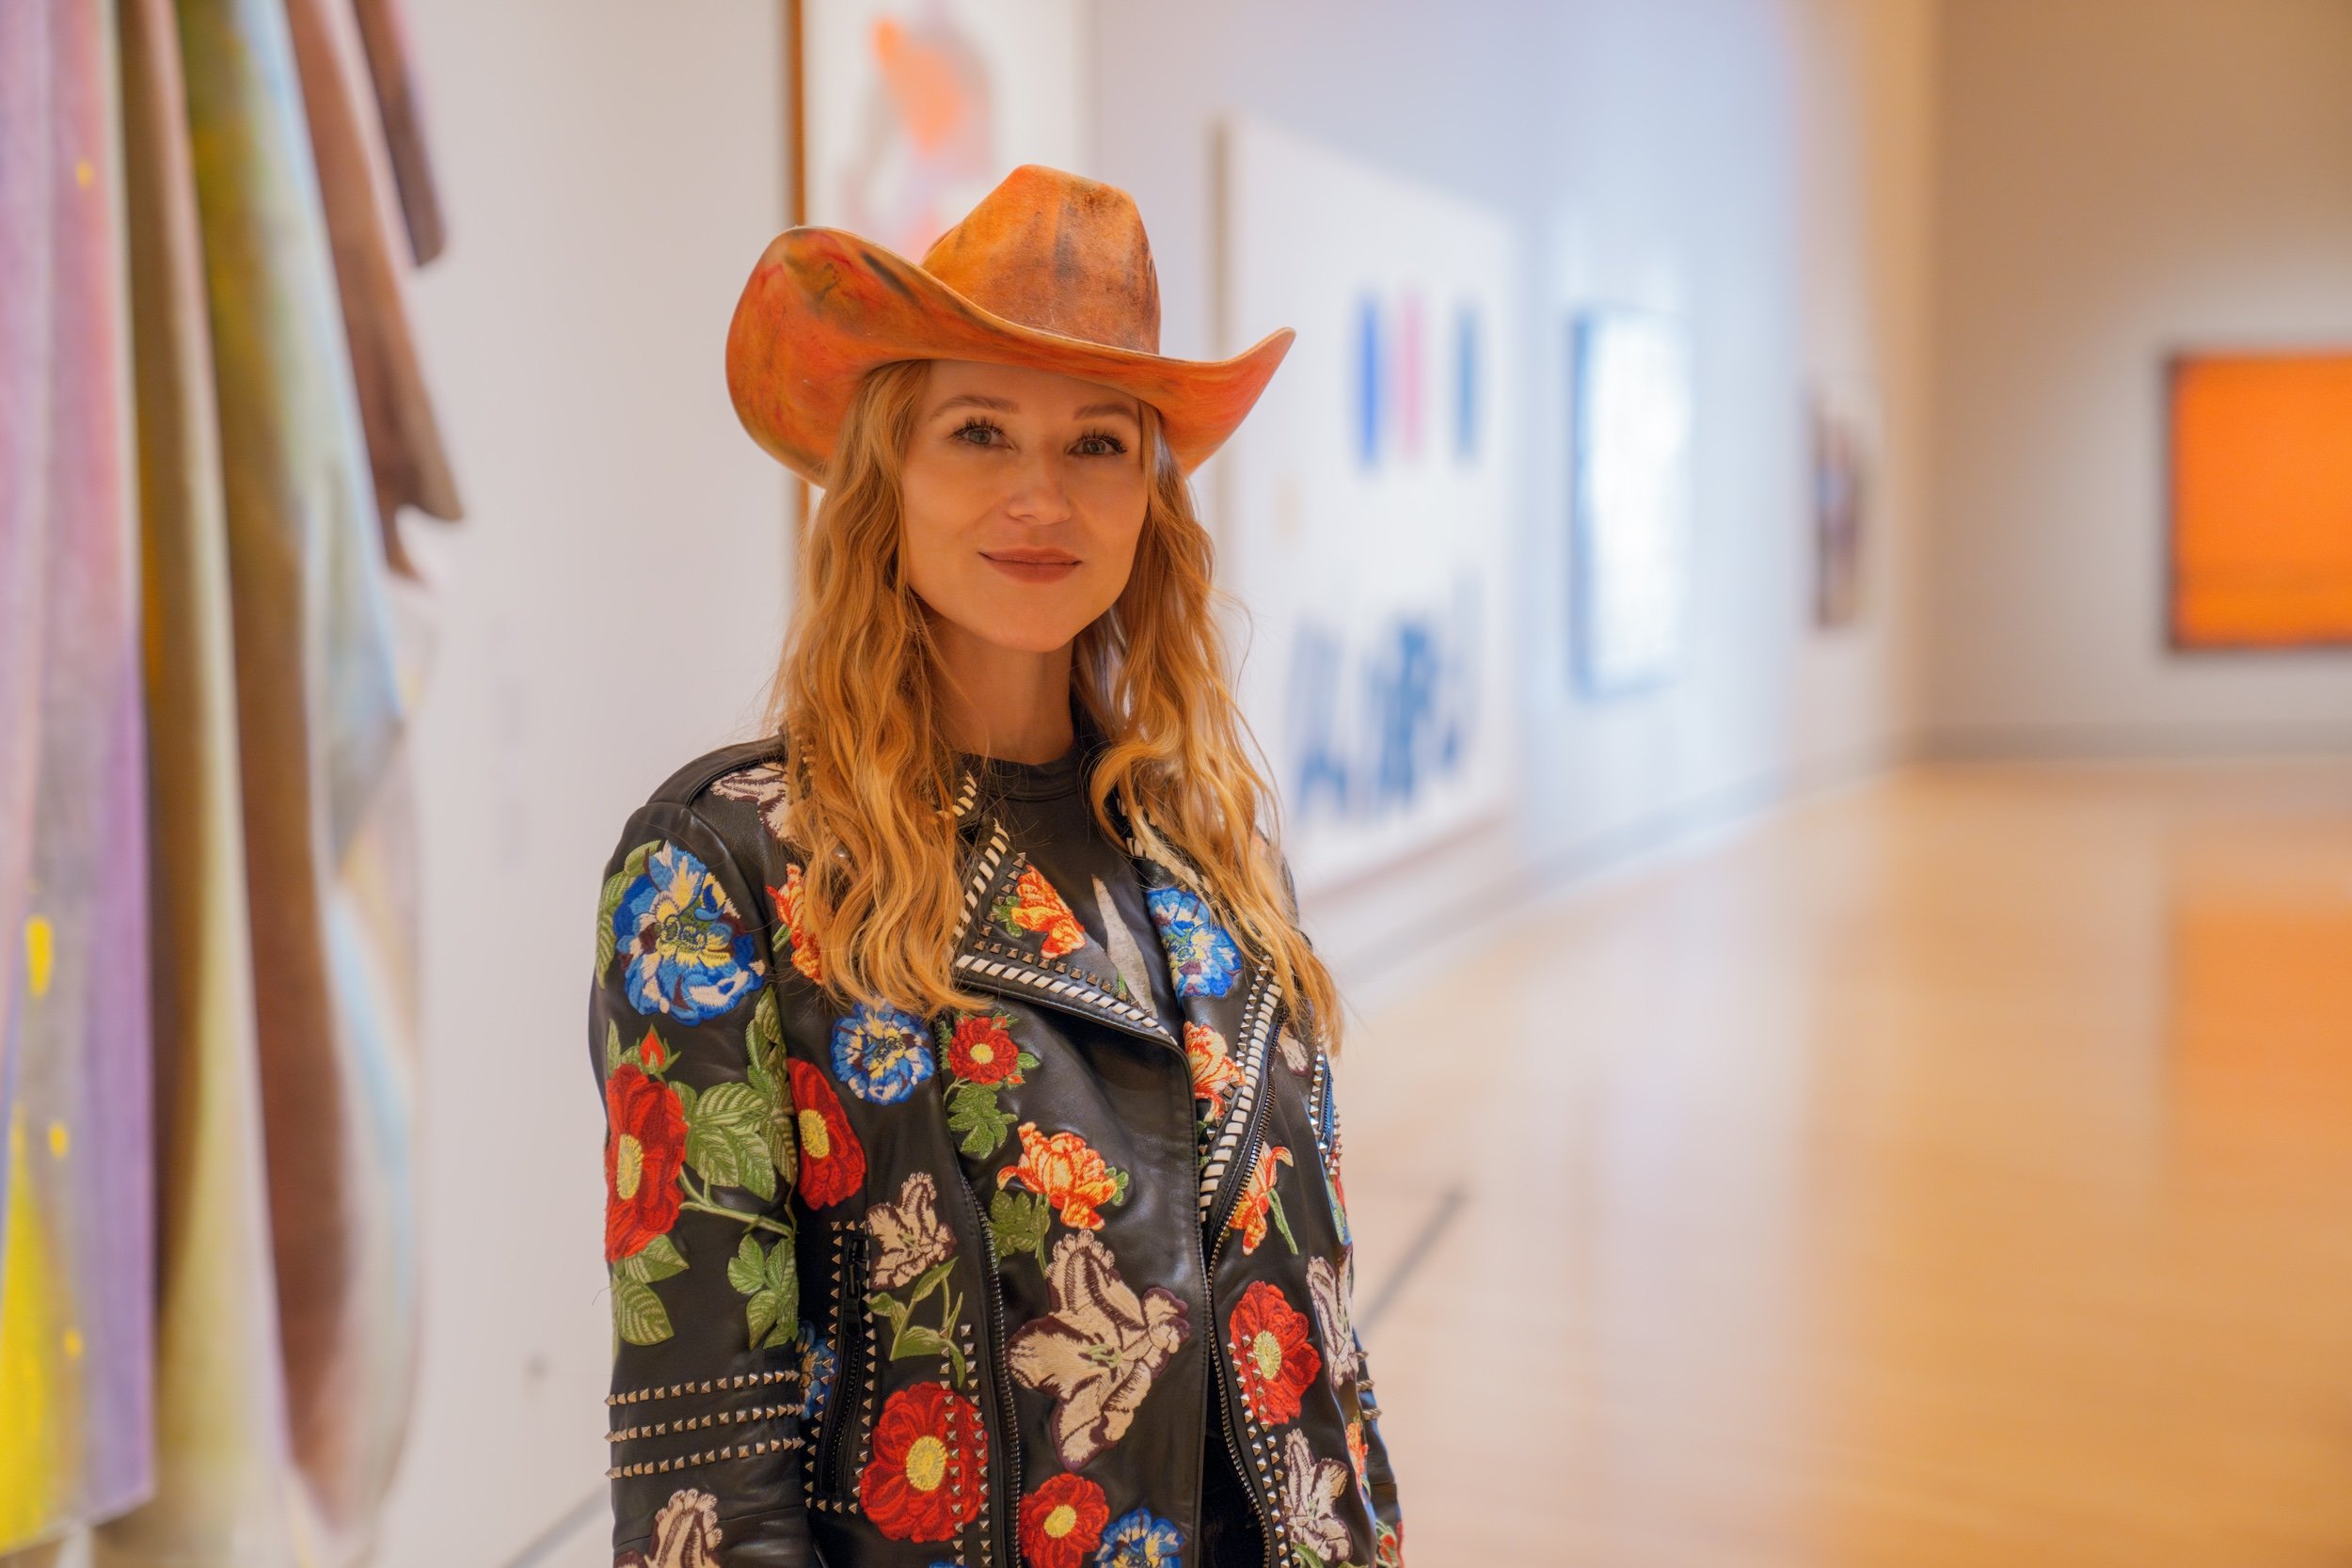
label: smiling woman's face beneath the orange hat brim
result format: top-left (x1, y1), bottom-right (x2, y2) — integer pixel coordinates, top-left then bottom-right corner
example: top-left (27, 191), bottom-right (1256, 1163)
top-left (901, 359), bottom-right (1148, 654)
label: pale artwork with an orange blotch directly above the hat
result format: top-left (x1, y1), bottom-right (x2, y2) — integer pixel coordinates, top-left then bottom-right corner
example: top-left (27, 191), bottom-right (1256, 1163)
top-left (793, 0), bottom-right (1087, 261)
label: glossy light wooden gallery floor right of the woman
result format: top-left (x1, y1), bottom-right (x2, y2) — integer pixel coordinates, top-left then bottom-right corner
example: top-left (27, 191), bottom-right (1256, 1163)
top-left (1341, 764), bottom-right (2352, 1568)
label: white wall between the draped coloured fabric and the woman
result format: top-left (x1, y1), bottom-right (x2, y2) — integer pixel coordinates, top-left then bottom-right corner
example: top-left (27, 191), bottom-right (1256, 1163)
top-left (379, 0), bottom-right (786, 1568)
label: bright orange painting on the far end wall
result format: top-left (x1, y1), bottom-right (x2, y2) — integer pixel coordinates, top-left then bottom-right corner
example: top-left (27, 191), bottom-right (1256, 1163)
top-left (2167, 353), bottom-right (2352, 651)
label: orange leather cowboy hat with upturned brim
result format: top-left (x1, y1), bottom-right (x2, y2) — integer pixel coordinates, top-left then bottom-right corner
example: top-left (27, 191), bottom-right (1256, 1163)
top-left (727, 165), bottom-right (1294, 484)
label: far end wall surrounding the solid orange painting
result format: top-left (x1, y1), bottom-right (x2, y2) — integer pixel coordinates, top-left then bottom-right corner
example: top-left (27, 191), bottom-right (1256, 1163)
top-left (1929, 0), bottom-right (2352, 752)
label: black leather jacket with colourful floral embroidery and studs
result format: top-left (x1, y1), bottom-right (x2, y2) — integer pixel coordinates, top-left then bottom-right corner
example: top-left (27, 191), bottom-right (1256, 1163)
top-left (588, 743), bottom-right (1402, 1568)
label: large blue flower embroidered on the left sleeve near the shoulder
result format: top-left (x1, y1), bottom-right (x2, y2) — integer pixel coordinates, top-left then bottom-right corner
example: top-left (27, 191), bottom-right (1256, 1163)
top-left (612, 844), bottom-right (765, 1022)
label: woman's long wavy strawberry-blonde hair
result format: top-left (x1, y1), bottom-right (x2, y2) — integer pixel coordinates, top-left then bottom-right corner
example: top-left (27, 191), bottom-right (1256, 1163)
top-left (770, 359), bottom-right (1341, 1049)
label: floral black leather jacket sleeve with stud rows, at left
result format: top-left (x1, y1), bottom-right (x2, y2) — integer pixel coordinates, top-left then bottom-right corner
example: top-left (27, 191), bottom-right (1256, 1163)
top-left (588, 800), bottom-right (817, 1568)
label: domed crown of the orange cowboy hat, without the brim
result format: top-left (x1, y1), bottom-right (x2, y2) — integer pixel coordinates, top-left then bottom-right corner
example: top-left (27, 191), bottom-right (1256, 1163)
top-left (922, 162), bottom-right (1160, 355)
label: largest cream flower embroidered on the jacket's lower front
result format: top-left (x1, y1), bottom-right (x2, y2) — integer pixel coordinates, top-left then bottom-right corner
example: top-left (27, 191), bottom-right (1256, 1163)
top-left (1007, 1229), bottom-right (1193, 1469)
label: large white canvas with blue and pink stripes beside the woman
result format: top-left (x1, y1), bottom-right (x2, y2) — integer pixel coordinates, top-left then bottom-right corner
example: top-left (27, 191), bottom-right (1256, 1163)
top-left (1216, 119), bottom-right (1515, 891)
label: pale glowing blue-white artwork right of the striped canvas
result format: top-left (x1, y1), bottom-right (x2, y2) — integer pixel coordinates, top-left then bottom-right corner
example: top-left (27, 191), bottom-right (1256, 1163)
top-left (1569, 308), bottom-right (1692, 696)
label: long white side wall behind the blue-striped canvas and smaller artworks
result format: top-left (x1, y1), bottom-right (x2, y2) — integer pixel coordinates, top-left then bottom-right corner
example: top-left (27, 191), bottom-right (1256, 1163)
top-left (1096, 0), bottom-right (1933, 978)
